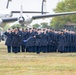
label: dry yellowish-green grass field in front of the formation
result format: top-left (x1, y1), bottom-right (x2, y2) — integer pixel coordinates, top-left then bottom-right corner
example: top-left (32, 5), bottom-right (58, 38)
top-left (0, 42), bottom-right (76, 75)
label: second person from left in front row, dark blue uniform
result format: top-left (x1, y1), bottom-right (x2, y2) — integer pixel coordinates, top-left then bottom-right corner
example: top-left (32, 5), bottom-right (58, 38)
top-left (12, 28), bottom-right (21, 53)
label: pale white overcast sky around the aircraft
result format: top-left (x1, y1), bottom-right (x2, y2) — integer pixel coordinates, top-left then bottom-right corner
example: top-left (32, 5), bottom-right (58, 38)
top-left (0, 0), bottom-right (61, 23)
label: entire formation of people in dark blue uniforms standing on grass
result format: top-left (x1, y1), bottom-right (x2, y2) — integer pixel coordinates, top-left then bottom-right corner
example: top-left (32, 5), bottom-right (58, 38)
top-left (4, 28), bottom-right (76, 54)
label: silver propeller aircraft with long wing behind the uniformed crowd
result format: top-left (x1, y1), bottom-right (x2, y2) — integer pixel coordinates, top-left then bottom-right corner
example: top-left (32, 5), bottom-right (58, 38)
top-left (0, 0), bottom-right (76, 27)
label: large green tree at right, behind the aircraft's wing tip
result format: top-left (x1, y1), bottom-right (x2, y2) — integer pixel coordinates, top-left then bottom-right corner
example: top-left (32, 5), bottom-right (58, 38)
top-left (50, 0), bottom-right (76, 29)
